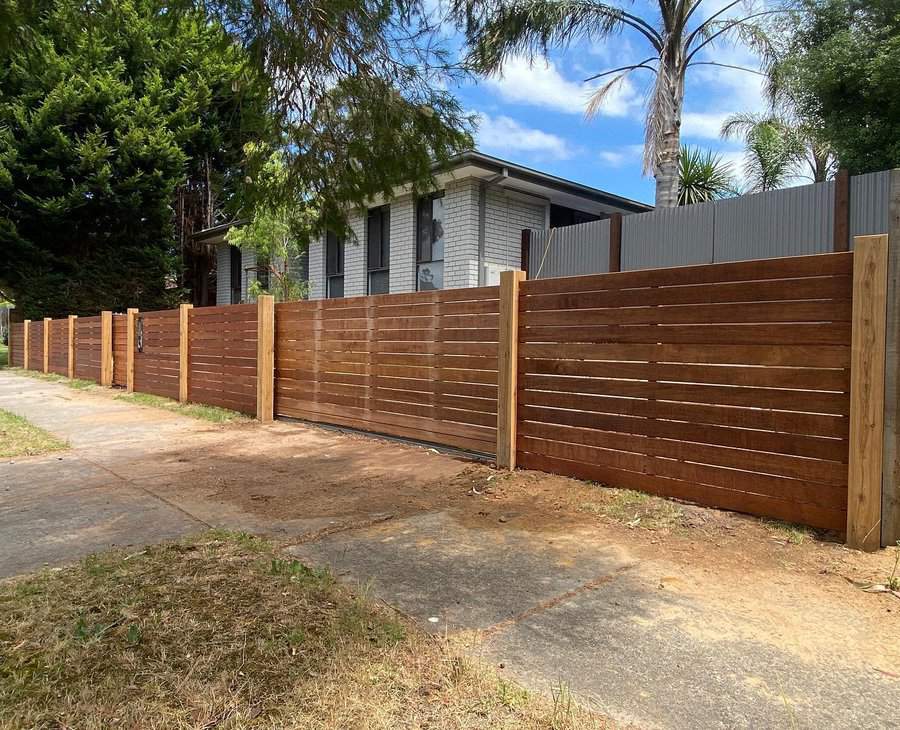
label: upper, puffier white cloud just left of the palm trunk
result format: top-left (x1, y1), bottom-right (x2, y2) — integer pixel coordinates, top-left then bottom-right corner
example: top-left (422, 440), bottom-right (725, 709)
top-left (484, 56), bottom-right (641, 117)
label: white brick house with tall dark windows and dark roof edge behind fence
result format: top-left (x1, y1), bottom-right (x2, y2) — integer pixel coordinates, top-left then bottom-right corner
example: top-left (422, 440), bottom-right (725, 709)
top-left (207, 151), bottom-right (650, 304)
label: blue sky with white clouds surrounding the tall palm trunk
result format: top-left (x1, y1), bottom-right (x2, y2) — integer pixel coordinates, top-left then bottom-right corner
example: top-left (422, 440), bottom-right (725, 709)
top-left (440, 0), bottom-right (765, 203)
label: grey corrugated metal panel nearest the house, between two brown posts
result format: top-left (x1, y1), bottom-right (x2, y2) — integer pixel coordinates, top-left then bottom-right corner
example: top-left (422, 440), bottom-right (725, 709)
top-left (528, 219), bottom-right (609, 279)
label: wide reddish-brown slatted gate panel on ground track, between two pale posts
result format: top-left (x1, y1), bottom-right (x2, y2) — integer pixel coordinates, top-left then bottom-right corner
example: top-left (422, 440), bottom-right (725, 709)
top-left (275, 286), bottom-right (500, 454)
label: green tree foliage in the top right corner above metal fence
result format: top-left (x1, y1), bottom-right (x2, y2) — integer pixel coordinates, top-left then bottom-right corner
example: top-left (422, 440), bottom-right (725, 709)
top-left (774, 0), bottom-right (900, 174)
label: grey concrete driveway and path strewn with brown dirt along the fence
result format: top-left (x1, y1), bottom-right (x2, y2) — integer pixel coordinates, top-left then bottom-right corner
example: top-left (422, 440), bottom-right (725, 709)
top-left (0, 371), bottom-right (900, 728)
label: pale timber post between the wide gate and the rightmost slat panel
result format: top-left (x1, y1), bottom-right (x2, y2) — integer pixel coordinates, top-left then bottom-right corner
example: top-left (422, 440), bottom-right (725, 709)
top-left (497, 271), bottom-right (526, 469)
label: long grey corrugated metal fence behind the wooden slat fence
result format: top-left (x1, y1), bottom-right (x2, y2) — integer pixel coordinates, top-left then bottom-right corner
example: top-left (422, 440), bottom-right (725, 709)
top-left (528, 171), bottom-right (891, 279)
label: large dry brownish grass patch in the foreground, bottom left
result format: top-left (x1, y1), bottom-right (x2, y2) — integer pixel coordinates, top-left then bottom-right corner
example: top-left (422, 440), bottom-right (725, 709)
top-left (0, 531), bottom-right (604, 729)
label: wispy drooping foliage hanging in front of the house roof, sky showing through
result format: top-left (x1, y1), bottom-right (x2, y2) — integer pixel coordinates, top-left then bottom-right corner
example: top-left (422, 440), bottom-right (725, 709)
top-left (205, 0), bottom-right (472, 231)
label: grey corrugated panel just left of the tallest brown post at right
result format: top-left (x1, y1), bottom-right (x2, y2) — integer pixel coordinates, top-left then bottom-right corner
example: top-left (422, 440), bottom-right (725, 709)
top-left (712, 182), bottom-right (834, 263)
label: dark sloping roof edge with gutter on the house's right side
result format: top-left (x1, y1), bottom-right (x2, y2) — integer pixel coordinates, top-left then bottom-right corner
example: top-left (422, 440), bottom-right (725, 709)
top-left (444, 150), bottom-right (653, 213)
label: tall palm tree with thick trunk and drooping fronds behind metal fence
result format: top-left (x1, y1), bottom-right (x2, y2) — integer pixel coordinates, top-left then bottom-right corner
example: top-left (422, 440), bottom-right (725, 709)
top-left (453, 0), bottom-right (780, 207)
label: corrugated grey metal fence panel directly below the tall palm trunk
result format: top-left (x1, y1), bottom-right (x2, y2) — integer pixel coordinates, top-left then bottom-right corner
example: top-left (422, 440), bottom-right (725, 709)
top-left (624, 203), bottom-right (716, 273)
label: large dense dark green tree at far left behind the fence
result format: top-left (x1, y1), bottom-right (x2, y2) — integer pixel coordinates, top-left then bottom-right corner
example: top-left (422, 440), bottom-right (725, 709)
top-left (0, 0), bottom-right (267, 316)
